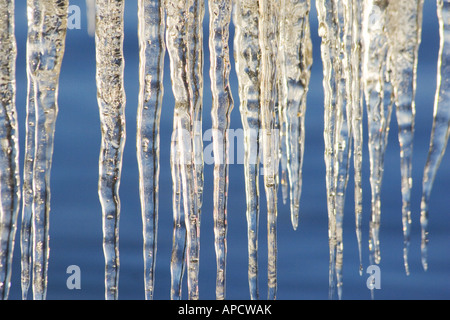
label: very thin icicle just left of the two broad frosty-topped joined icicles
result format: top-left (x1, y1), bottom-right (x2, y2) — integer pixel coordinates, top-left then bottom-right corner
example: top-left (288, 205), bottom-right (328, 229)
top-left (351, 0), bottom-right (363, 275)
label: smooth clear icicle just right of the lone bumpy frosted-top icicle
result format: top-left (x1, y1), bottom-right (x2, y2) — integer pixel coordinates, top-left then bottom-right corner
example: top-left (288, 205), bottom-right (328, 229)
top-left (136, 0), bottom-right (165, 299)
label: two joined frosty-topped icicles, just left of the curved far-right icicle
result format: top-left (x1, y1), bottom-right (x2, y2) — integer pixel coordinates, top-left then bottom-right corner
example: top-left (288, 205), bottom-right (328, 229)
top-left (363, 0), bottom-right (423, 273)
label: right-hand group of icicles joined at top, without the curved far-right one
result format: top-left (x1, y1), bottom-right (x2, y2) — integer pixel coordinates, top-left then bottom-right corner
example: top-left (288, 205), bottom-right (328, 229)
top-left (316, 0), bottom-right (423, 298)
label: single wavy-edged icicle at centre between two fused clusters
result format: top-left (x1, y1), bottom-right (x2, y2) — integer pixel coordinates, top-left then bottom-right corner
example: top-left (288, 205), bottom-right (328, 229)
top-left (208, 0), bottom-right (234, 300)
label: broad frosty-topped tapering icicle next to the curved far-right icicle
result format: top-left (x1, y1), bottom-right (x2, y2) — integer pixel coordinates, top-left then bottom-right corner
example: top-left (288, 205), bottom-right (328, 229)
top-left (387, 0), bottom-right (423, 274)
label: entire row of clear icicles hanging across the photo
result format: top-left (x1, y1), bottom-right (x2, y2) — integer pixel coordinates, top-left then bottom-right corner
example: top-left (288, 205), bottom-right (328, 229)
top-left (0, 0), bottom-right (450, 299)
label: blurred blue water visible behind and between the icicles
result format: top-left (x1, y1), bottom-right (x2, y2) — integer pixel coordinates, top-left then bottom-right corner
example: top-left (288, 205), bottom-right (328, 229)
top-left (5, 0), bottom-right (450, 299)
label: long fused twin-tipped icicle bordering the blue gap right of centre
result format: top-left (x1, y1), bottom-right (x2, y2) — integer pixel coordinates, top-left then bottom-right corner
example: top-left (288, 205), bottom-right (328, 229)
top-left (317, 0), bottom-right (353, 298)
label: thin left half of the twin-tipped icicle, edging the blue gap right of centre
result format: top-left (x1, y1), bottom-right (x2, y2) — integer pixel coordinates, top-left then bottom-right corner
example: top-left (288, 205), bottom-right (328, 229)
top-left (316, 0), bottom-right (337, 299)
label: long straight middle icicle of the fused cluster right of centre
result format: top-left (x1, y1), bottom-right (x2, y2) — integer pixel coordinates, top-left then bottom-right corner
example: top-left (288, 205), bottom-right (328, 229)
top-left (259, 0), bottom-right (279, 300)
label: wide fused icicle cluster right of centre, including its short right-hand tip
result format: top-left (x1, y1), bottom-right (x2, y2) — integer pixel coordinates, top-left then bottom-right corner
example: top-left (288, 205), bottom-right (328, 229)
top-left (234, 0), bottom-right (312, 299)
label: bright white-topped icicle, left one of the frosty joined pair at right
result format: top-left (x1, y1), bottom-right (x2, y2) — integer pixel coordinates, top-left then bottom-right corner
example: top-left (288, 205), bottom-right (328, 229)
top-left (362, 0), bottom-right (392, 264)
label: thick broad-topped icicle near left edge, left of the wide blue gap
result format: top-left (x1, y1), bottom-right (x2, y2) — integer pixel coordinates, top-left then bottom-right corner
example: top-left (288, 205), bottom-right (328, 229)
top-left (22, 0), bottom-right (68, 300)
